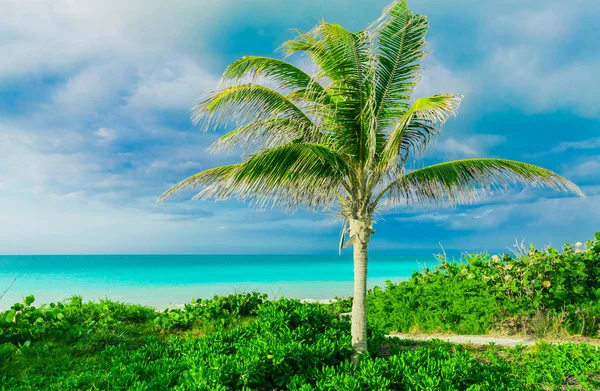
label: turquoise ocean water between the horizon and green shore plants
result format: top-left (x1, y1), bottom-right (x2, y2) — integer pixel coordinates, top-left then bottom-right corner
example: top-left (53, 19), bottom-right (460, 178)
top-left (0, 255), bottom-right (438, 309)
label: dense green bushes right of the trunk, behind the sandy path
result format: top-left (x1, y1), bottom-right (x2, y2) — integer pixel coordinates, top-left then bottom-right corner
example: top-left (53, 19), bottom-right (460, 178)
top-left (368, 233), bottom-right (600, 338)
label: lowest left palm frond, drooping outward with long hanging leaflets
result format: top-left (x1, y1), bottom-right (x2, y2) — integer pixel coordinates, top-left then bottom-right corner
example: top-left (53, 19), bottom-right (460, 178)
top-left (160, 144), bottom-right (350, 209)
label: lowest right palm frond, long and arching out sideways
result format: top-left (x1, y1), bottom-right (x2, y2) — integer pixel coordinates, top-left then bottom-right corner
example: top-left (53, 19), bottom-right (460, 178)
top-left (378, 158), bottom-right (583, 210)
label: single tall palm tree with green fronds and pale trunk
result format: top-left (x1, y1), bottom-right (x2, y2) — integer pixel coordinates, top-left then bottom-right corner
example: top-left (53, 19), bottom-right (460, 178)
top-left (160, 1), bottom-right (582, 353)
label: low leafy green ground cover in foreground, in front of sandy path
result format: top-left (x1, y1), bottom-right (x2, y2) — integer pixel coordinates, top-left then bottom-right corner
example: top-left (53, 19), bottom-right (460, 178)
top-left (0, 294), bottom-right (600, 391)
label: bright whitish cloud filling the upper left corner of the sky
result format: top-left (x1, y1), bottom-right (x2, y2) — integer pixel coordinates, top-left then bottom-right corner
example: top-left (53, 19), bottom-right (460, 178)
top-left (0, 0), bottom-right (226, 81)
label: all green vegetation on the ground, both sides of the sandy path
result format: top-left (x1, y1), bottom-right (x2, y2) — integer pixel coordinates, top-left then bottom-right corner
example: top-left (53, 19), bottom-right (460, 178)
top-left (0, 234), bottom-right (600, 391)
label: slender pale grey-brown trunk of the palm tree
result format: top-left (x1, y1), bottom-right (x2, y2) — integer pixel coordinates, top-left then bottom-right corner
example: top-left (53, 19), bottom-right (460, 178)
top-left (350, 220), bottom-right (371, 354)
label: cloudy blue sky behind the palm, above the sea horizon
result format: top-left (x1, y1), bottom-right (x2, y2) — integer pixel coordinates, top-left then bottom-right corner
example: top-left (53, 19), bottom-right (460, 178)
top-left (0, 0), bottom-right (600, 254)
